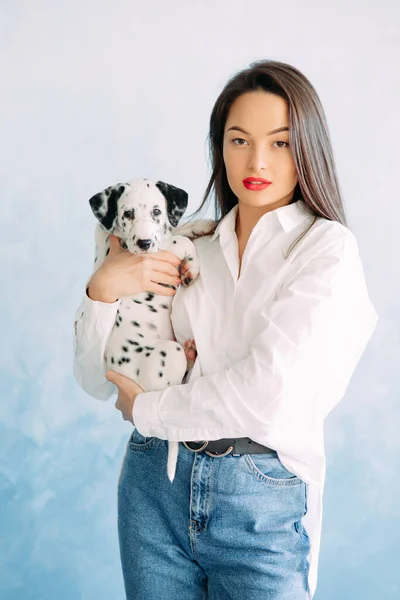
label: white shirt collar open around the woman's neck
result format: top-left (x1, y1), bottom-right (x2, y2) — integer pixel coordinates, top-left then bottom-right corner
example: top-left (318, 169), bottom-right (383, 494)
top-left (211, 200), bottom-right (312, 241)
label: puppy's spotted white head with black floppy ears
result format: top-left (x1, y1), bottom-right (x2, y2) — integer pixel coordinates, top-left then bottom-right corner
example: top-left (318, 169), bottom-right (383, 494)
top-left (89, 179), bottom-right (188, 254)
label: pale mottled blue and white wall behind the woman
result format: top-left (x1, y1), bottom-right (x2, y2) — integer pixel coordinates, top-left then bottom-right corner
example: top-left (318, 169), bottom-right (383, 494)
top-left (0, 0), bottom-right (400, 600)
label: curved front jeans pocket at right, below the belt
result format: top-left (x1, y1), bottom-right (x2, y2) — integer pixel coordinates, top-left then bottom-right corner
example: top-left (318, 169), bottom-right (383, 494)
top-left (244, 452), bottom-right (303, 486)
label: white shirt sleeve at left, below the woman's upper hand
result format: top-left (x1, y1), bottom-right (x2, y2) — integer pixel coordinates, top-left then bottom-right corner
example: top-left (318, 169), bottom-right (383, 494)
top-left (73, 292), bottom-right (121, 400)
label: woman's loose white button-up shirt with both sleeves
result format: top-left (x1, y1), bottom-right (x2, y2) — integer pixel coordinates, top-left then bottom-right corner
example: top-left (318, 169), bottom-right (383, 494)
top-left (74, 200), bottom-right (378, 594)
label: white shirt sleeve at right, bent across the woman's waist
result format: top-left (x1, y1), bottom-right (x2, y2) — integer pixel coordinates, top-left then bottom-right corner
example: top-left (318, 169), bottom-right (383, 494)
top-left (133, 231), bottom-right (377, 448)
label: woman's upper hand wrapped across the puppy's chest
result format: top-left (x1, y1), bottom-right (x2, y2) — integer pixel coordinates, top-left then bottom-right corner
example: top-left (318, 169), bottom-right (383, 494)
top-left (88, 235), bottom-right (181, 302)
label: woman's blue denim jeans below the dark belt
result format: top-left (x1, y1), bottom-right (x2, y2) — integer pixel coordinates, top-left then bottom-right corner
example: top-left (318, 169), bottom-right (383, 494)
top-left (118, 429), bottom-right (310, 600)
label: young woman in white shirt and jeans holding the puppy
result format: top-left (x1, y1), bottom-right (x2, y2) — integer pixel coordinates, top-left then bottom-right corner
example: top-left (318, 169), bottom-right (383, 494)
top-left (74, 61), bottom-right (377, 600)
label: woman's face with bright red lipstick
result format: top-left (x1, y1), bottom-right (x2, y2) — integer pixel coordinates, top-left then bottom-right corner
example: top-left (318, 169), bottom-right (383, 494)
top-left (223, 91), bottom-right (297, 210)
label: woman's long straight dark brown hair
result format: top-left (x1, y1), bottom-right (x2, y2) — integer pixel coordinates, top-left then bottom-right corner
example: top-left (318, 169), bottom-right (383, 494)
top-left (191, 60), bottom-right (347, 251)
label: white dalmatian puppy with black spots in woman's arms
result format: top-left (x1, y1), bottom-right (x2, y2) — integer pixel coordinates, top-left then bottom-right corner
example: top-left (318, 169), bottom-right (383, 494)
top-left (89, 179), bottom-right (215, 482)
